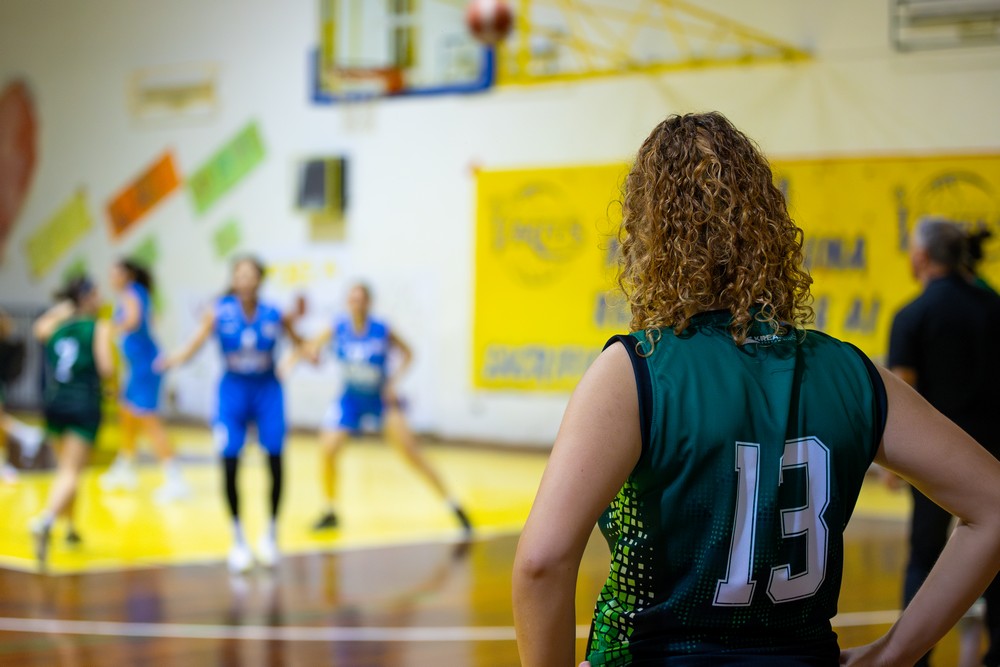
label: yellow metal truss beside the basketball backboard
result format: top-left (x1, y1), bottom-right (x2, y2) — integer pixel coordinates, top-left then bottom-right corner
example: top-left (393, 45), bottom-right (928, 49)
top-left (497, 0), bottom-right (810, 85)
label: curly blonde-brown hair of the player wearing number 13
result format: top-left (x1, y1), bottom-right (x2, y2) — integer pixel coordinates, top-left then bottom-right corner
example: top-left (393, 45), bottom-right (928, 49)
top-left (618, 112), bottom-right (813, 353)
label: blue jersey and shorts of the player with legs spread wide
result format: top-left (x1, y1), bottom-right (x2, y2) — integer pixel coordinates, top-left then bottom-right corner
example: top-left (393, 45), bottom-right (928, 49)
top-left (324, 317), bottom-right (391, 432)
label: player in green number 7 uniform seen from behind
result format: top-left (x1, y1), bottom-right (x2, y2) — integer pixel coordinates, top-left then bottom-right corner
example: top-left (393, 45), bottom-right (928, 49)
top-left (31, 277), bottom-right (114, 568)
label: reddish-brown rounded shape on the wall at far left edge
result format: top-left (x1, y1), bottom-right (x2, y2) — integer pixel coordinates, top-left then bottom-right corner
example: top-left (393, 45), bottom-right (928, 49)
top-left (0, 81), bottom-right (38, 262)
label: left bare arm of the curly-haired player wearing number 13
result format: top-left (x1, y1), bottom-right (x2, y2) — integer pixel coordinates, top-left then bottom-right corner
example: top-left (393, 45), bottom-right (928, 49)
top-left (514, 345), bottom-right (642, 667)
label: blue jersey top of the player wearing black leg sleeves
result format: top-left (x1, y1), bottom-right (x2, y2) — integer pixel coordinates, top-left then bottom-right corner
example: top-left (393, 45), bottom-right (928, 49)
top-left (215, 296), bottom-right (282, 375)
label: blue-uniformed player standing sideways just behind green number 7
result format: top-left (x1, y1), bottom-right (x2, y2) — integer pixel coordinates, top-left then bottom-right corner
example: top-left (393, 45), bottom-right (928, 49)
top-left (101, 259), bottom-right (190, 502)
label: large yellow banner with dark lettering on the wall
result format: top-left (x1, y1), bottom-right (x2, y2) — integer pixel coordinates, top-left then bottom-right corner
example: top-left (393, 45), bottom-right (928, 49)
top-left (473, 155), bottom-right (1000, 391)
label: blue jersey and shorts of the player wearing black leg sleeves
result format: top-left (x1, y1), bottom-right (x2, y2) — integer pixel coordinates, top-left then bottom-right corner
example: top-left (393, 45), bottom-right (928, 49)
top-left (214, 296), bottom-right (285, 458)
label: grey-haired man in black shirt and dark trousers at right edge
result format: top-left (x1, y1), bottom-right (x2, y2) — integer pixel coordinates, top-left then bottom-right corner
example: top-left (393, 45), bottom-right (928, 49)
top-left (888, 219), bottom-right (1000, 667)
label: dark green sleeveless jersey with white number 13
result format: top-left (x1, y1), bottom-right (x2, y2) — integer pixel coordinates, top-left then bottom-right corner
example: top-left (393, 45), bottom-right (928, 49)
top-left (588, 312), bottom-right (885, 667)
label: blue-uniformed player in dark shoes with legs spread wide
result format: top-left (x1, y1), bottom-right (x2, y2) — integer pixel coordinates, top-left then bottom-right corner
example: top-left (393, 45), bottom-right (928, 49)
top-left (302, 284), bottom-right (471, 531)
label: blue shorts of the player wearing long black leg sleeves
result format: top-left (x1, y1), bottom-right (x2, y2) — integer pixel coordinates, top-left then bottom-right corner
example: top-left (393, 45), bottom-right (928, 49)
top-left (213, 373), bottom-right (285, 458)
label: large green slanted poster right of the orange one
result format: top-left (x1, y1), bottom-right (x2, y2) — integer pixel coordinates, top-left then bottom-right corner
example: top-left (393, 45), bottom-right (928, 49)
top-left (188, 123), bottom-right (264, 215)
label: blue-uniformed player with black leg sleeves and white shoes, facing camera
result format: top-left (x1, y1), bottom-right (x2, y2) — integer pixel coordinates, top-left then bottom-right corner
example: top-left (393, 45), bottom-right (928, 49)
top-left (163, 257), bottom-right (301, 572)
